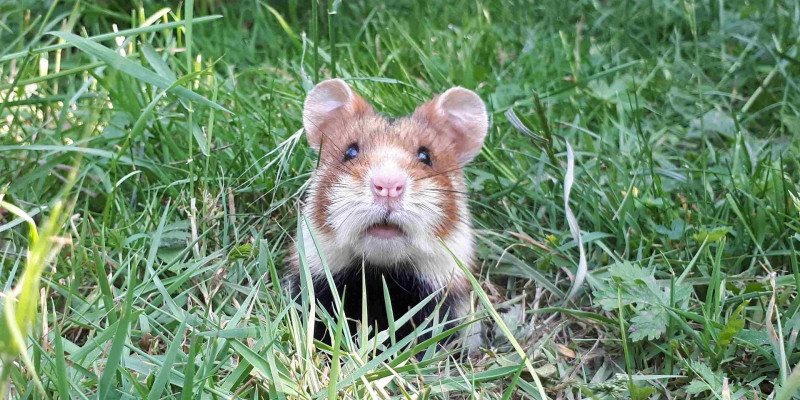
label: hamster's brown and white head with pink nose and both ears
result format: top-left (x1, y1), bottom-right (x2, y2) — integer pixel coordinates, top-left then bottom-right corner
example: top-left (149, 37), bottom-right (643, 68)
top-left (303, 79), bottom-right (488, 265)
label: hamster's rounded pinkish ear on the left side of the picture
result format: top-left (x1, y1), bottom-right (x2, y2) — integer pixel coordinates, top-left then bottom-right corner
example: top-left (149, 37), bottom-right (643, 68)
top-left (303, 79), bottom-right (372, 150)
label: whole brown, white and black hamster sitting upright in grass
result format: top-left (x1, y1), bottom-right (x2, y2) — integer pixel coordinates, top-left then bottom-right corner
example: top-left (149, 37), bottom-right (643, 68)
top-left (285, 79), bottom-right (488, 350)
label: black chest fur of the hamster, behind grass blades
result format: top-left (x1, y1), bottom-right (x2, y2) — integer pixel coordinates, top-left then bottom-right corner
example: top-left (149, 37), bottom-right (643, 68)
top-left (295, 260), bottom-right (454, 341)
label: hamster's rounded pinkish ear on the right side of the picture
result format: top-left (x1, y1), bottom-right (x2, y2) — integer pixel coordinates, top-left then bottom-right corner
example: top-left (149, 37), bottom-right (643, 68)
top-left (414, 86), bottom-right (489, 165)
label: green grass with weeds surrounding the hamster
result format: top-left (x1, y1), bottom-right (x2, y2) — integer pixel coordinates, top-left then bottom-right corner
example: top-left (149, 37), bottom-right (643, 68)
top-left (0, 0), bottom-right (800, 400)
